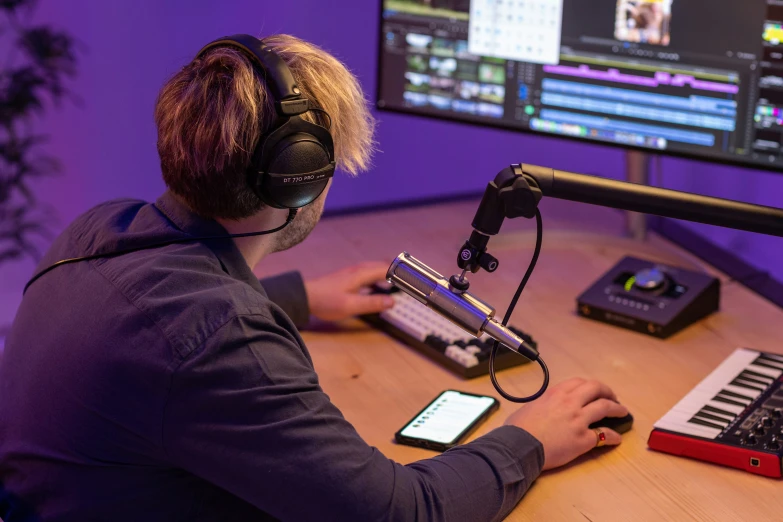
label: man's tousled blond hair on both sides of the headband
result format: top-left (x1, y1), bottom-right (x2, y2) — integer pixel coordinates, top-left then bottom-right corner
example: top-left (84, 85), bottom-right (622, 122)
top-left (155, 34), bottom-right (375, 219)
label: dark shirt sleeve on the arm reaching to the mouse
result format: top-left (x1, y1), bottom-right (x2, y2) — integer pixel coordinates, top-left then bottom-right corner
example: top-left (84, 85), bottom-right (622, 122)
top-left (163, 316), bottom-right (544, 522)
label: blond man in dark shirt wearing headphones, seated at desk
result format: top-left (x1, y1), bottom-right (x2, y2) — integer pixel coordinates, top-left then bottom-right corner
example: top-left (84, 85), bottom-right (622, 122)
top-left (0, 35), bottom-right (627, 522)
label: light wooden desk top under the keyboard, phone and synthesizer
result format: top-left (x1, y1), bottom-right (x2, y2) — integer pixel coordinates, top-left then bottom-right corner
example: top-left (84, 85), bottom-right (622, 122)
top-left (258, 201), bottom-right (783, 522)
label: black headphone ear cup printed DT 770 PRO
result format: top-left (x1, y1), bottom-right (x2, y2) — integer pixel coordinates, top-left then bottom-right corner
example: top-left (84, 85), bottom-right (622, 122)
top-left (253, 120), bottom-right (335, 209)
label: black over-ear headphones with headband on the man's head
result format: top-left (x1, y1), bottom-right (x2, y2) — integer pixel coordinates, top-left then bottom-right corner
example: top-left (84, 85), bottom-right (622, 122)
top-left (196, 34), bottom-right (335, 209)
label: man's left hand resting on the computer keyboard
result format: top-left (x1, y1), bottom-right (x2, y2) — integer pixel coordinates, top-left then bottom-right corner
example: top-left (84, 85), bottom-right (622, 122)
top-left (305, 263), bottom-right (394, 321)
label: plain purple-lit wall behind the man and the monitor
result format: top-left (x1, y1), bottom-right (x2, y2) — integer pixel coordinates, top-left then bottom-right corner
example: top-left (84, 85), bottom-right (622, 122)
top-left (0, 0), bottom-right (783, 334)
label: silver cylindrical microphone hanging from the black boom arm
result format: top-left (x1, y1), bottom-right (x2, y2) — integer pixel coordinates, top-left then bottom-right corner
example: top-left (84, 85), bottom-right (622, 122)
top-left (386, 252), bottom-right (538, 361)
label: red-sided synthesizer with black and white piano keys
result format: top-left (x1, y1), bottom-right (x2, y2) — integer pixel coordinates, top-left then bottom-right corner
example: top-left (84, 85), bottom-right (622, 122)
top-left (648, 349), bottom-right (783, 477)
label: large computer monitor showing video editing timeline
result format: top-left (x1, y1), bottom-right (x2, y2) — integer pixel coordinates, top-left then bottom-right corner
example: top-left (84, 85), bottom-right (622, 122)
top-left (377, 0), bottom-right (783, 169)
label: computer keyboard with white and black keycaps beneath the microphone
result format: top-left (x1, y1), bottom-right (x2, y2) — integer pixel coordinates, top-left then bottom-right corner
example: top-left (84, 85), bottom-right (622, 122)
top-left (363, 287), bottom-right (537, 379)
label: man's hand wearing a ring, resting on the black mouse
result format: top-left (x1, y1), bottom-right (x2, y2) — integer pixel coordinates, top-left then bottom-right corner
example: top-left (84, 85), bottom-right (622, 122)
top-left (506, 378), bottom-right (628, 469)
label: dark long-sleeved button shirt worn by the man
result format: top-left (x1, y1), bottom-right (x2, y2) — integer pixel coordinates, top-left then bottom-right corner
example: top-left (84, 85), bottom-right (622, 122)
top-left (0, 194), bottom-right (543, 522)
